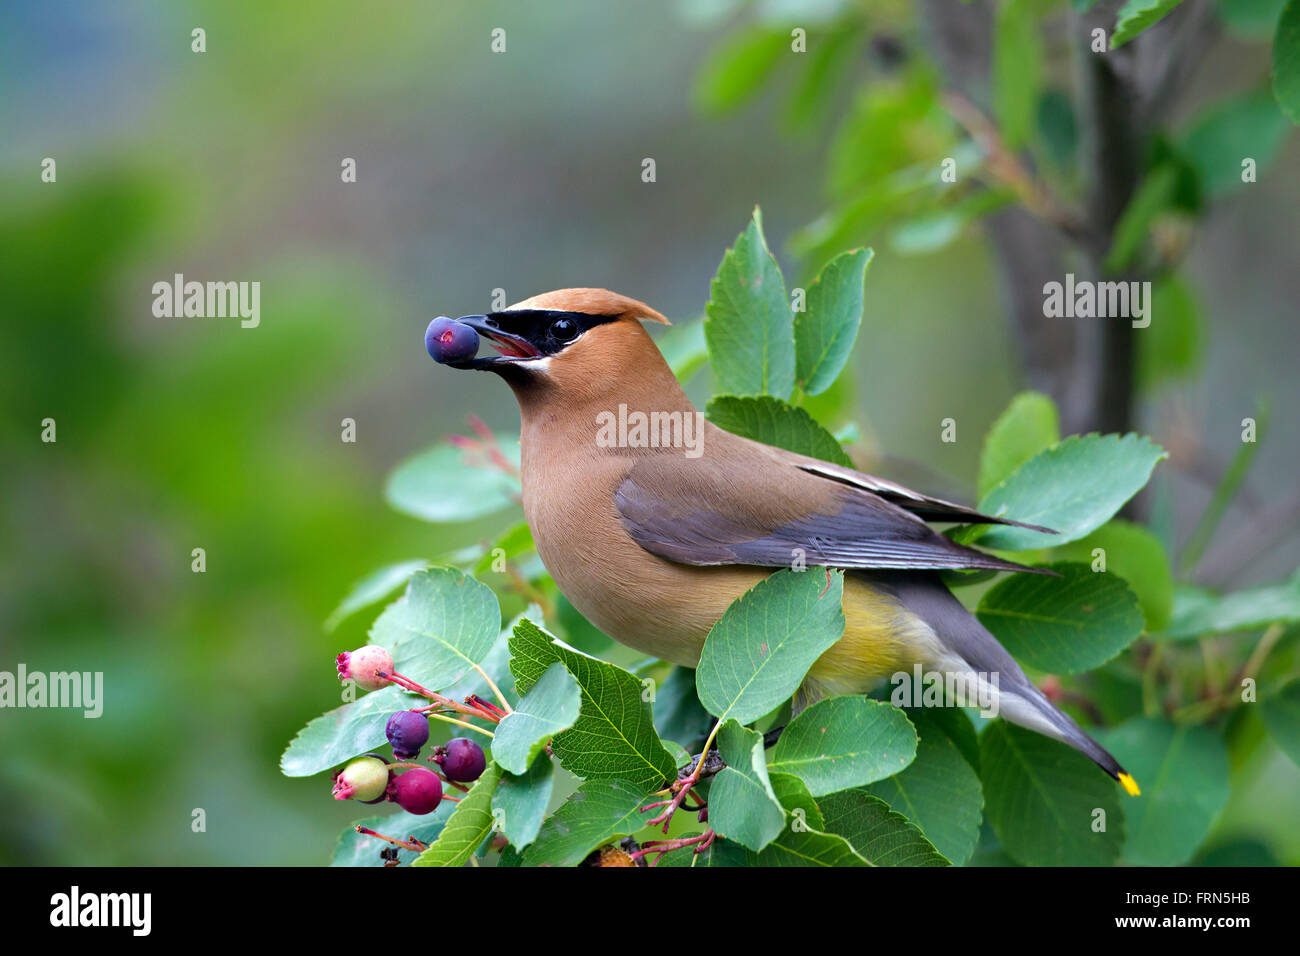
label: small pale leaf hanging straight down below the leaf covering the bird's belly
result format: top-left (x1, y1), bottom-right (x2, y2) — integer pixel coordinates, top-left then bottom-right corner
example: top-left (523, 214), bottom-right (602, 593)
top-left (709, 721), bottom-right (785, 851)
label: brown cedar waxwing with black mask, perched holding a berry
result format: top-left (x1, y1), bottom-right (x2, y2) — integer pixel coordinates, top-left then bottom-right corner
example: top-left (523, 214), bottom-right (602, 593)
top-left (429, 289), bottom-right (1138, 795)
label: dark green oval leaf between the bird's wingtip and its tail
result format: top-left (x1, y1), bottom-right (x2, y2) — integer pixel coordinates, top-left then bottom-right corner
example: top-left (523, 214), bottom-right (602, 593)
top-left (976, 562), bottom-right (1143, 674)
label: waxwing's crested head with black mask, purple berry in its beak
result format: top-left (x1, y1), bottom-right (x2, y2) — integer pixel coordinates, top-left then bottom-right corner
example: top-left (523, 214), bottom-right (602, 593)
top-left (425, 289), bottom-right (671, 402)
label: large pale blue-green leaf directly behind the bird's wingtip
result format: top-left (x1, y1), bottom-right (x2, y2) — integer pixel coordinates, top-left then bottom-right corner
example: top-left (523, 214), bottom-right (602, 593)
top-left (979, 434), bottom-right (1169, 551)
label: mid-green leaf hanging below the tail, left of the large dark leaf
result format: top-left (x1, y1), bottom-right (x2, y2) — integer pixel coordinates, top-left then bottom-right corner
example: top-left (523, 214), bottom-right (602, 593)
top-left (867, 708), bottom-right (984, 865)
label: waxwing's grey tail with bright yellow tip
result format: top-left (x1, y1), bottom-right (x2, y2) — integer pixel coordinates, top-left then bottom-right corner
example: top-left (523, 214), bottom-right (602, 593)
top-left (876, 575), bottom-right (1140, 796)
